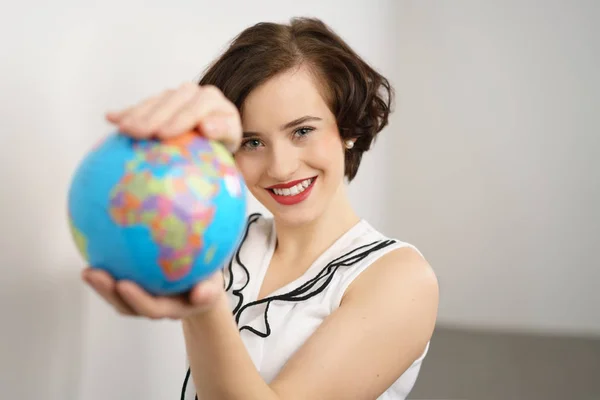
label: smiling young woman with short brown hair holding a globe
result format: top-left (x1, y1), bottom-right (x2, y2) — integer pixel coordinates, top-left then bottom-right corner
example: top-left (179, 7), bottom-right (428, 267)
top-left (83, 19), bottom-right (438, 400)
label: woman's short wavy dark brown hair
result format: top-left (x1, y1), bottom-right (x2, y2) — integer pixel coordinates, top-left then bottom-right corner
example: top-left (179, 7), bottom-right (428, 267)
top-left (199, 18), bottom-right (393, 181)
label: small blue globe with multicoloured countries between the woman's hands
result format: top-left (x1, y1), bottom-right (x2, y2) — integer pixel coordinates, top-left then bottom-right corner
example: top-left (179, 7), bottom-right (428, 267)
top-left (67, 132), bottom-right (247, 295)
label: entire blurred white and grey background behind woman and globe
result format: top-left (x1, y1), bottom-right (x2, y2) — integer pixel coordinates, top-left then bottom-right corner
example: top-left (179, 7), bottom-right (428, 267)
top-left (0, 0), bottom-right (600, 400)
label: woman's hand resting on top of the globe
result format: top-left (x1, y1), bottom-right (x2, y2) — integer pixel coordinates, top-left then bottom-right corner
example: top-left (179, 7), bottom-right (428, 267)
top-left (106, 82), bottom-right (242, 152)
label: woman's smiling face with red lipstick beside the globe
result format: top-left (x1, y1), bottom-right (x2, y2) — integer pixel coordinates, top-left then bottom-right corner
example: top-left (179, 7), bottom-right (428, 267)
top-left (235, 68), bottom-right (344, 224)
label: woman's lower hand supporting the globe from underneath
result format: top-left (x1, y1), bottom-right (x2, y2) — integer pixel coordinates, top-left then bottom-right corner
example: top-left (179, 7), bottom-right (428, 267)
top-left (82, 268), bottom-right (225, 320)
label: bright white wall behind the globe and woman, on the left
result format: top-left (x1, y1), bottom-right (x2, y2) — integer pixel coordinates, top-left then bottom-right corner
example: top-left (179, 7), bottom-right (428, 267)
top-left (0, 0), bottom-right (394, 400)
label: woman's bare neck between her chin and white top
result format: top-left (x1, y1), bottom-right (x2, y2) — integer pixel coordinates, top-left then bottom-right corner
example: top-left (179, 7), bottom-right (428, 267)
top-left (275, 185), bottom-right (360, 262)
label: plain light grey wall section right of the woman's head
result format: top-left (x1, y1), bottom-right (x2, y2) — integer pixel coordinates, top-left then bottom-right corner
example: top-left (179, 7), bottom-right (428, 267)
top-left (392, 0), bottom-right (600, 335)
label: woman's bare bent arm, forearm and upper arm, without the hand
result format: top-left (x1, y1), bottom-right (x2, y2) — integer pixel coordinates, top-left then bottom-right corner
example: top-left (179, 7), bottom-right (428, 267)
top-left (183, 248), bottom-right (438, 400)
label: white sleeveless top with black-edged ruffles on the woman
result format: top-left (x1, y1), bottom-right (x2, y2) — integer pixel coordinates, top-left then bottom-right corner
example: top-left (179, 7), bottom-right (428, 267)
top-left (181, 214), bottom-right (429, 400)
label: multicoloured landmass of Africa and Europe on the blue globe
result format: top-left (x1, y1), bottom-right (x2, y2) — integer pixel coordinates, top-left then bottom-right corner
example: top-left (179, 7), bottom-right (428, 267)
top-left (110, 135), bottom-right (241, 280)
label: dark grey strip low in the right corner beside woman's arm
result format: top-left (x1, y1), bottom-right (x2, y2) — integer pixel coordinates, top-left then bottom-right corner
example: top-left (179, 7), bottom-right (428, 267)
top-left (409, 327), bottom-right (600, 400)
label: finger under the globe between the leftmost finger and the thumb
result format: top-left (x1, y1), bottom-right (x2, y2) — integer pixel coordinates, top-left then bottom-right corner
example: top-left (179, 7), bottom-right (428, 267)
top-left (117, 281), bottom-right (185, 319)
